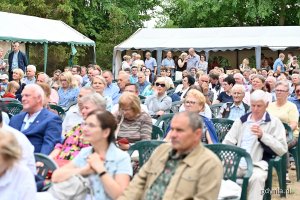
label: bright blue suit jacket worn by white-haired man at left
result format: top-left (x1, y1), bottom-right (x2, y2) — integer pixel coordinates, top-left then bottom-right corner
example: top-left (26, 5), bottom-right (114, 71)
top-left (9, 108), bottom-right (62, 155)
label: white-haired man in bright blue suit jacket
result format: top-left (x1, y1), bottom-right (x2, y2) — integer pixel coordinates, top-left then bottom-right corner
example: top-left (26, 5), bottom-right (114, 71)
top-left (9, 84), bottom-right (62, 155)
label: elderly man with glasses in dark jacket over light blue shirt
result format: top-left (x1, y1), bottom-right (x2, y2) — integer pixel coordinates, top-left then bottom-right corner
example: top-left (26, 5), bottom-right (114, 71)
top-left (218, 84), bottom-right (250, 120)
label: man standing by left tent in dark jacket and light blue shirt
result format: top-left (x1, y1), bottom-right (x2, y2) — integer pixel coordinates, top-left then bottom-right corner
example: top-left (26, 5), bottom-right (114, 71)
top-left (8, 42), bottom-right (28, 80)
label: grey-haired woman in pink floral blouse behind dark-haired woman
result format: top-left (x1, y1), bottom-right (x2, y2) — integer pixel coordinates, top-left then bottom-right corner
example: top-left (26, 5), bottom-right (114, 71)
top-left (49, 93), bottom-right (106, 160)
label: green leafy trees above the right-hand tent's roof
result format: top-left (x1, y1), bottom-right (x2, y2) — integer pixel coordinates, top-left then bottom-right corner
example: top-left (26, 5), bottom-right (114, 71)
top-left (163, 0), bottom-right (300, 28)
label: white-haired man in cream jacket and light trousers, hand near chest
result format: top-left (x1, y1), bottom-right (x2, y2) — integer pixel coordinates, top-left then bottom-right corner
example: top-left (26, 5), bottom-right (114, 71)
top-left (223, 90), bottom-right (288, 200)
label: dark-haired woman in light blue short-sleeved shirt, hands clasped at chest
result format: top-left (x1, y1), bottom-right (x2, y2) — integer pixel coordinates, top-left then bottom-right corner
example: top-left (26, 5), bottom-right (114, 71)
top-left (52, 111), bottom-right (132, 200)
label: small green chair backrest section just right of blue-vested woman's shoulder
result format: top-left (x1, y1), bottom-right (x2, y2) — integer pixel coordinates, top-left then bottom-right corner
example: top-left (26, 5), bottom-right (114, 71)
top-left (211, 118), bottom-right (234, 143)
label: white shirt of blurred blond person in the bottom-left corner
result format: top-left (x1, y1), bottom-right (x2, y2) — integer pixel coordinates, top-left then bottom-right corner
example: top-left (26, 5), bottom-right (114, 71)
top-left (0, 163), bottom-right (36, 200)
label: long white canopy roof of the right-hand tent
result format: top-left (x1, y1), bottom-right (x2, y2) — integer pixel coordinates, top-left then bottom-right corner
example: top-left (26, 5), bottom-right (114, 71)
top-left (113, 26), bottom-right (300, 73)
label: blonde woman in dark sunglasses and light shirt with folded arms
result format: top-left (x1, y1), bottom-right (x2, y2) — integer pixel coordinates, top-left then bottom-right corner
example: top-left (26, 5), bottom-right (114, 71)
top-left (145, 77), bottom-right (172, 118)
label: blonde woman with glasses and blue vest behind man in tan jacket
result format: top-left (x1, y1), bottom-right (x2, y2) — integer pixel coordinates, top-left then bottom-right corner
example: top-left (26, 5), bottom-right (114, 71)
top-left (165, 89), bottom-right (218, 144)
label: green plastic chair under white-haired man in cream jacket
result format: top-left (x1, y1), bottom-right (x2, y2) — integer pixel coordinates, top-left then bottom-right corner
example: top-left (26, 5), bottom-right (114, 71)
top-left (264, 123), bottom-right (293, 200)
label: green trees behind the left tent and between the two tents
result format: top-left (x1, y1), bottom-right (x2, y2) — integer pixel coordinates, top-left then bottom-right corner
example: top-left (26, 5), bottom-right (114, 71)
top-left (0, 0), bottom-right (161, 73)
